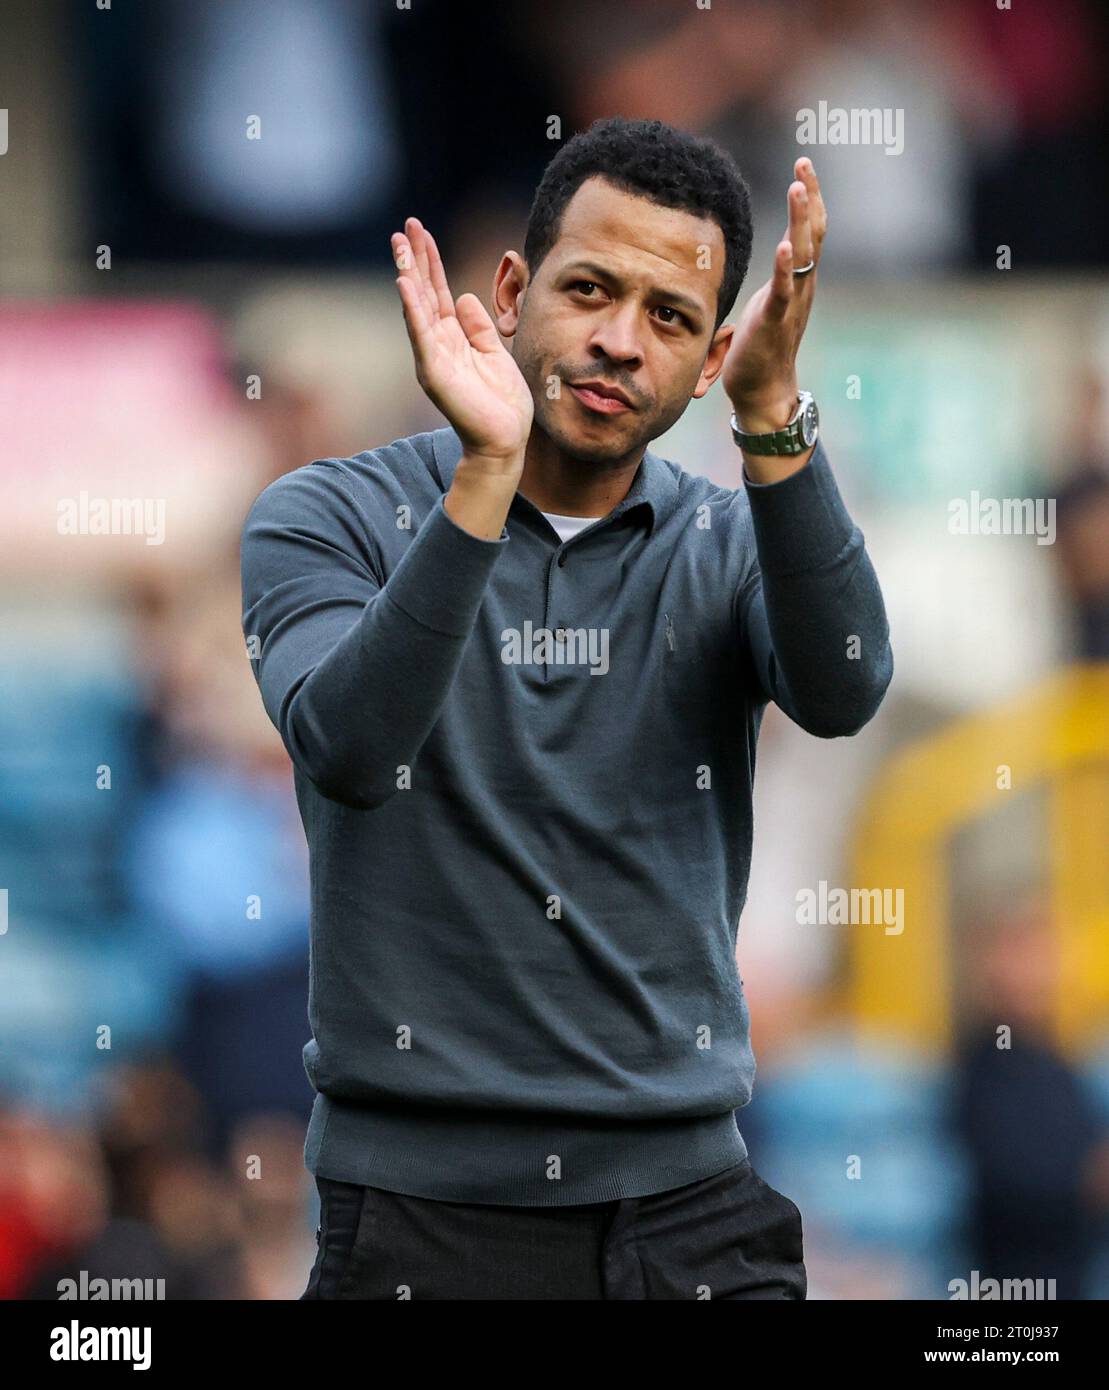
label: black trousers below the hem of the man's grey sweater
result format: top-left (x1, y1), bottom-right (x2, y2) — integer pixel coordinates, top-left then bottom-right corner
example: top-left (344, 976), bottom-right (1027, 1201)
top-left (300, 1159), bottom-right (807, 1302)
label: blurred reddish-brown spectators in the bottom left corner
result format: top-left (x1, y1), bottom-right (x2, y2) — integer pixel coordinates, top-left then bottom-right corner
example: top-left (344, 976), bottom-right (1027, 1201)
top-left (0, 1061), bottom-right (315, 1300)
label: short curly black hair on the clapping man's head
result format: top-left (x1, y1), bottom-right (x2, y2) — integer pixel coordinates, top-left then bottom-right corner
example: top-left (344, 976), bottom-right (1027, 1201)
top-left (524, 115), bottom-right (752, 331)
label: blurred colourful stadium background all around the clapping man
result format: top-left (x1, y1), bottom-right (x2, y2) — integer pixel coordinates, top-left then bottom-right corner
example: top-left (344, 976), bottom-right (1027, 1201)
top-left (0, 0), bottom-right (1109, 1300)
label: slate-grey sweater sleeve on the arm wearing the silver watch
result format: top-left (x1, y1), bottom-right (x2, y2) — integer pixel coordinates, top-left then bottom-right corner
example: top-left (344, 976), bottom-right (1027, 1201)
top-left (735, 442), bottom-right (894, 738)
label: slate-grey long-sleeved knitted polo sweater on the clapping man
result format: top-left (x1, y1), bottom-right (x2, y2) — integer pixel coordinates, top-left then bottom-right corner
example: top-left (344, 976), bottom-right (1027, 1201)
top-left (242, 428), bottom-right (892, 1205)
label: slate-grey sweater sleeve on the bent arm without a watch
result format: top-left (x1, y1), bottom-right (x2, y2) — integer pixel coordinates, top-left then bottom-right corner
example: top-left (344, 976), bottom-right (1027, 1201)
top-left (242, 463), bottom-right (509, 809)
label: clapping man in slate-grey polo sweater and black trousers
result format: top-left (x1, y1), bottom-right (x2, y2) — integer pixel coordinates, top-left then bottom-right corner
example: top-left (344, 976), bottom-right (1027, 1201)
top-left (243, 118), bottom-right (892, 1300)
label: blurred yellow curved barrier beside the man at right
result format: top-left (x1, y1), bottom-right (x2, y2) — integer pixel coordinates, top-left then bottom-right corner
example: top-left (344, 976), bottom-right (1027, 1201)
top-left (848, 663), bottom-right (1109, 1051)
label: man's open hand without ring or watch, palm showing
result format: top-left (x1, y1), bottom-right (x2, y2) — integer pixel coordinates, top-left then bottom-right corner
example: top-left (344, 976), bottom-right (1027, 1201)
top-left (392, 217), bottom-right (534, 485)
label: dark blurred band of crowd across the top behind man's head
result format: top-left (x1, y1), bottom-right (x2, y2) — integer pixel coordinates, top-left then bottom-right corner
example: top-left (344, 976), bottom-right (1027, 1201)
top-left (54, 0), bottom-right (1109, 277)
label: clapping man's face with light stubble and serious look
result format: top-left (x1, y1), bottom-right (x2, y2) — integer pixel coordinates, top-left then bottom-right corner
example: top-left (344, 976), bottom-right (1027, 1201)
top-left (495, 178), bottom-right (731, 463)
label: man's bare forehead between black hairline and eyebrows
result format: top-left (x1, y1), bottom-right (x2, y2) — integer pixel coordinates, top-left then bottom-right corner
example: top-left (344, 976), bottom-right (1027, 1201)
top-left (549, 177), bottom-right (724, 306)
